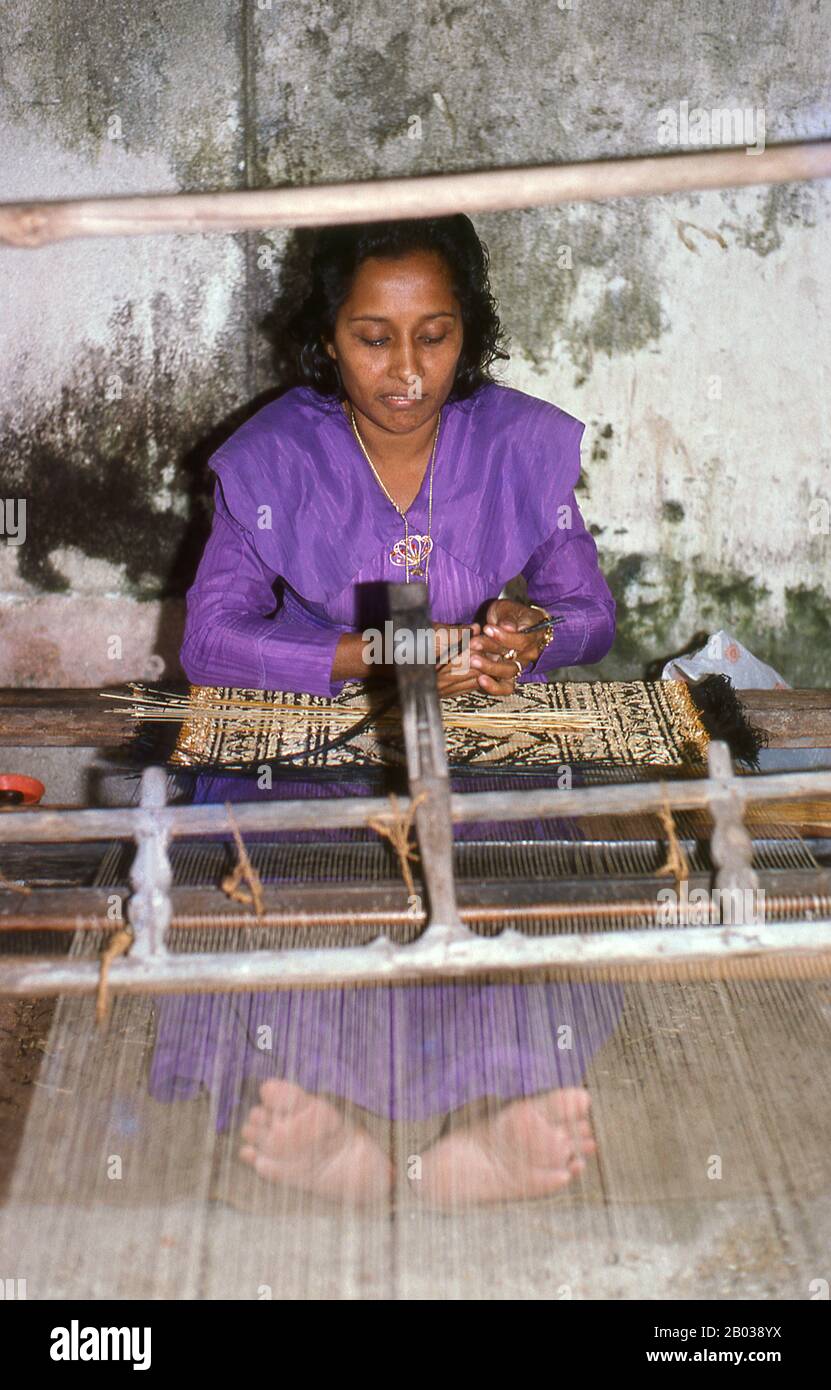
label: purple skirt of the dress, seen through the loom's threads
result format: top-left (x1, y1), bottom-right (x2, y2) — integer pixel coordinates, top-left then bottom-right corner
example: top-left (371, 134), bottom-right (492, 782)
top-left (150, 777), bottom-right (623, 1130)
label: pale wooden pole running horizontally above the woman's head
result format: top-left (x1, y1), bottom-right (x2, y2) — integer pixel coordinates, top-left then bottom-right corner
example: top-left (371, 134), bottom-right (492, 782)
top-left (0, 140), bottom-right (831, 247)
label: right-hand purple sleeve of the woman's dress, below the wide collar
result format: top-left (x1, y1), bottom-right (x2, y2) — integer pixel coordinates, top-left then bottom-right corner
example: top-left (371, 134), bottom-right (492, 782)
top-left (518, 425), bottom-right (616, 681)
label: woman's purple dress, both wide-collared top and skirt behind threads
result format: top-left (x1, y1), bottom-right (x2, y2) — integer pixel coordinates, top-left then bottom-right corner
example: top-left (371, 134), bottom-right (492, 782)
top-left (150, 385), bottom-right (621, 1129)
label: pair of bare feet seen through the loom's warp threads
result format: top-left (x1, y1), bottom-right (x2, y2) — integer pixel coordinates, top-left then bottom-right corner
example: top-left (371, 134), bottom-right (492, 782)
top-left (239, 1079), bottom-right (598, 1207)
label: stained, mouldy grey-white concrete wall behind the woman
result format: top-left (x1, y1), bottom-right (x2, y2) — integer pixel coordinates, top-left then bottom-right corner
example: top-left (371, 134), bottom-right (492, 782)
top-left (0, 0), bottom-right (831, 685)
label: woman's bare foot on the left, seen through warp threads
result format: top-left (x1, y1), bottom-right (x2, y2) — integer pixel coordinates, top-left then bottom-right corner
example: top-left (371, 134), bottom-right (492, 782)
top-left (239, 1079), bottom-right (392, 1202)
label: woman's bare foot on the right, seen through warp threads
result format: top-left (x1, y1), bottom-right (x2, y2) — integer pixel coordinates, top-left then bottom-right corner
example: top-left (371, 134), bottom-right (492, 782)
top-left (411, 1087), bottom-right (598, 1207)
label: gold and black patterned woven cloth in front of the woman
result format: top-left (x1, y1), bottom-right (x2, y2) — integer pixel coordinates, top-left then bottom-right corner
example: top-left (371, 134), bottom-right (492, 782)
top-left (164, 681), bottom-right (709, 769)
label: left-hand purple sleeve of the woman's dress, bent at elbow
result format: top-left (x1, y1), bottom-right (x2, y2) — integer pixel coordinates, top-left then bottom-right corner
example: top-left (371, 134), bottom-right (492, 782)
top-left (179, 482), bottom-right (343, 695)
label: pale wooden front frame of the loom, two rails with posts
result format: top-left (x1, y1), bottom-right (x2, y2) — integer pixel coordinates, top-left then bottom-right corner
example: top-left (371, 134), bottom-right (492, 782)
top-left (0, 584), bottom-right (831, 995)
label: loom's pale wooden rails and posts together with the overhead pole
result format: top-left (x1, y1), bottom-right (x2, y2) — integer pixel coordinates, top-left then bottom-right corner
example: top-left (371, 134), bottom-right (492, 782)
top-left (0, 140), bottom-right (831, 994)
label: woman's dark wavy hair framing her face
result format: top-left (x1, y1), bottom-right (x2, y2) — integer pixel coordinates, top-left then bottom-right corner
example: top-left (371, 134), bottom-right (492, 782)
top-left (288, 213), bottom-right (509, 400)
